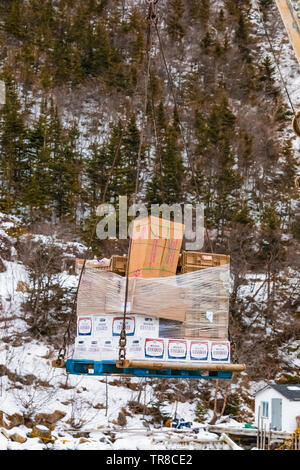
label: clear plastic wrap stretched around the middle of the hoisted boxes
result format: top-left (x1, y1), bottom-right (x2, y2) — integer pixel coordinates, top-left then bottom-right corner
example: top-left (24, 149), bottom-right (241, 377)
top-left (77, 264), bottom-right (230, 340)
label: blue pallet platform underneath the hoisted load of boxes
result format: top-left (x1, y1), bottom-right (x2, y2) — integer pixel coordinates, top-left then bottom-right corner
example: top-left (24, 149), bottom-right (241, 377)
top-left (66, 359), bottom-right (232, 379)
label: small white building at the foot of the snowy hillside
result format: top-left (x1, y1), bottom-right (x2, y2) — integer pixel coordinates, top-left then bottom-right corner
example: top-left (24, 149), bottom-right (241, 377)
top-left (255, 384), bottom-right (300, 433)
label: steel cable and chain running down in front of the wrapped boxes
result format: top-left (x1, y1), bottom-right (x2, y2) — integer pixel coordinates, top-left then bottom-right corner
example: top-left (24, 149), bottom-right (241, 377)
top-left (119, 0), bottom-right (159, 365)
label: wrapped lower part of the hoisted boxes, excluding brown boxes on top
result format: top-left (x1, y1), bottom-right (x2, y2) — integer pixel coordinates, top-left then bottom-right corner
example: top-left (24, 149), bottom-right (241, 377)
top-left (72, 264), bottom-right (229, 362)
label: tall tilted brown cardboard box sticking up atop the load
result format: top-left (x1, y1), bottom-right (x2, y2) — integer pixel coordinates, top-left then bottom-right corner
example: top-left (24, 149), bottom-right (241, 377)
top-left (128, 216), bottom-right (184, 278)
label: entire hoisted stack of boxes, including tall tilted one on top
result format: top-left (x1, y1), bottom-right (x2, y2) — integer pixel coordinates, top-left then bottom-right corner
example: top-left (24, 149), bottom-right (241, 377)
top-left (74, 217), bottom-right (230, 362)
